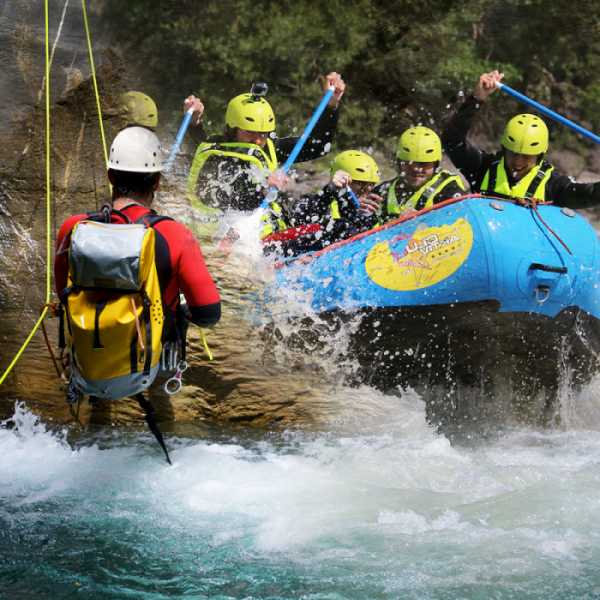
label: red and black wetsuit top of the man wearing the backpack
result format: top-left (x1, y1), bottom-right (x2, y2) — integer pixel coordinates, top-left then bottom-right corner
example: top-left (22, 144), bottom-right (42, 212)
top-left (54, 204), bottom-right (221, 327)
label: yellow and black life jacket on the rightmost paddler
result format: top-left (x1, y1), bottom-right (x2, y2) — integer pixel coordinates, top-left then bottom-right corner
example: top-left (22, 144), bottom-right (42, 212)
top-left (480, 158), bottom-right (554, 201)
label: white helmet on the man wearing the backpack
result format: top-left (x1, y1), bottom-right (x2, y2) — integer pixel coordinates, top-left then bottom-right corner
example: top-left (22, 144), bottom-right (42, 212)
top-left (108, 127), bottom-right (163, 173)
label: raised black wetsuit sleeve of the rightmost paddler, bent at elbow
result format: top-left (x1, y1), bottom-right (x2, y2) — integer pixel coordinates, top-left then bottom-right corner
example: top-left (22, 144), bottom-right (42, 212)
top-left (441, 95), bottom-right (499, 192)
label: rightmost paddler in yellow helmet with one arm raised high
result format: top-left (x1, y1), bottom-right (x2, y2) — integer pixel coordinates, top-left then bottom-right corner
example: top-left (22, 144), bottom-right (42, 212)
top-left (442, 71), bottom-right (600, 208)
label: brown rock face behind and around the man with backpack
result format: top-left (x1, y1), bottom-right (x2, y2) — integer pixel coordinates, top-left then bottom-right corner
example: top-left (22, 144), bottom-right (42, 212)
top-left (0, 13), bottom-right (346, 424)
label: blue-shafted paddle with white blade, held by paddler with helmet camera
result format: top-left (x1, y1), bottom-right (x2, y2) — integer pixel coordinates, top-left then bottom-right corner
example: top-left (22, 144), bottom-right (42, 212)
top-left (215, 86), bottom-right (335, 266)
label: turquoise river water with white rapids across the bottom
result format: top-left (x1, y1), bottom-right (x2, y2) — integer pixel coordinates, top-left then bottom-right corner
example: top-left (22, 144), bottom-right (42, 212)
top-left (0, 386), bottom-right (600, 600)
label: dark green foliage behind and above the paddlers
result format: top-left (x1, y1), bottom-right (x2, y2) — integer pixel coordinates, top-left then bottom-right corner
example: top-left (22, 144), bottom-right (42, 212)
top-left (102, 0), bottom-right (600, 155)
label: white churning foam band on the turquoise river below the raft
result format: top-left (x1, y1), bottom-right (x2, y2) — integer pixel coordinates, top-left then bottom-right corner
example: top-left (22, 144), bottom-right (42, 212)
top-left (0, 388), bottom-right (600, 564)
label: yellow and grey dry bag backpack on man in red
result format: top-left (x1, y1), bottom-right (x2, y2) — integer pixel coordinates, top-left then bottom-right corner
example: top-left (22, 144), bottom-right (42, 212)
top-left (62, 211), bottom-right (168, 399)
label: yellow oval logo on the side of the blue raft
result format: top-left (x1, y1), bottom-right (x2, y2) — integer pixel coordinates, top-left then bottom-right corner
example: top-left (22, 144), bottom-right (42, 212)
top-left (365, 219), bottom-right (473, 291)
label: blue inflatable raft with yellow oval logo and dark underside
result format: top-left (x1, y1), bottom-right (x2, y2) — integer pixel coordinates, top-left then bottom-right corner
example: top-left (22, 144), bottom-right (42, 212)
top-left (268, 195), bottom-right (600, 414)
